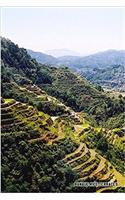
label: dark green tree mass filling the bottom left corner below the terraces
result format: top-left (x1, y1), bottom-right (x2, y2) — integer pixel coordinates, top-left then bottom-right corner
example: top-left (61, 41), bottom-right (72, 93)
top-left (1, 133), bottom-right (77, 192)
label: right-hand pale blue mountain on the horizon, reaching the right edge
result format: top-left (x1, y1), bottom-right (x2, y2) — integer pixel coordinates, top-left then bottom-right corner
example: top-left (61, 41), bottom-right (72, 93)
top-left (56, 50), bottom-right (125, 71)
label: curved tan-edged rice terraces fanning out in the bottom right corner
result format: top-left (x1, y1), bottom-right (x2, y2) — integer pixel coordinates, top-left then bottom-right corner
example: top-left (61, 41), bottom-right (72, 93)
top-left (64, 143), bottom-right (125, 192)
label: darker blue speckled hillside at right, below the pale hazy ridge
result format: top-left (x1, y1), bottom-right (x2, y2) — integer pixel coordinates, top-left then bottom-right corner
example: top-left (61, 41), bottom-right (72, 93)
top-left (81, 65), bottom-right (125, 92)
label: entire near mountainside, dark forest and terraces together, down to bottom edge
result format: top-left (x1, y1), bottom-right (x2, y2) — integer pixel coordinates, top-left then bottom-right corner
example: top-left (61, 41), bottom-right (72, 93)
top-left (1, 38), bottom-right (125, 192)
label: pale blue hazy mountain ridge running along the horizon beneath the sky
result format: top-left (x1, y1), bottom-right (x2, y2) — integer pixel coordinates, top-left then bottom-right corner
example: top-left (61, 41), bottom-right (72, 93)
top-left (27, 50), bottom-right (125, 71)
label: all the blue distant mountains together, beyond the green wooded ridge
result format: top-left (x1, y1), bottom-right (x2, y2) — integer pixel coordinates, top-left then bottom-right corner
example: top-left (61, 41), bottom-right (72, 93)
top-left (28, 50), bottom-right (125, 91)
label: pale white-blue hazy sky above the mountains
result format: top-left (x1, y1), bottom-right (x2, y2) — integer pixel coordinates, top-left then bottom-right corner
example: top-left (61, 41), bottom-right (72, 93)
top-left (2, 7), bottom-right (124, 54)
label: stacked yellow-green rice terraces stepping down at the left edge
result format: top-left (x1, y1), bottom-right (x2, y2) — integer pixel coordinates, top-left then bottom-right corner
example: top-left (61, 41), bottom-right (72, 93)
top-left (1, 99), bottom-right (52, 140)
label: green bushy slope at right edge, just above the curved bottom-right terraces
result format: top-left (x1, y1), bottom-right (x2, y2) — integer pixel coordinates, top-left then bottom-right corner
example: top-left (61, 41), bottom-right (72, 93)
top-left (81, 129), bottom-right (125, 175)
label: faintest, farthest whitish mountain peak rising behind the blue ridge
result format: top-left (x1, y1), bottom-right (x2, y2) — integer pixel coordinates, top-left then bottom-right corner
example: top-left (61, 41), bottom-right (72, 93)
top-left (46, 49), bottom-right (80, 58)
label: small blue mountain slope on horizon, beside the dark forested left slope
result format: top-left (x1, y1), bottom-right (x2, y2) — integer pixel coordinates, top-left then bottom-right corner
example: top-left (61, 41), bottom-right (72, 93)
top-left (27, 49), bottom-right (57, 65)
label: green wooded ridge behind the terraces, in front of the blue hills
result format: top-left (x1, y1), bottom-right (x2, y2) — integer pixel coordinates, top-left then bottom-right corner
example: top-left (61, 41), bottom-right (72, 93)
top-left (42, 68), bottom-right (124, 127)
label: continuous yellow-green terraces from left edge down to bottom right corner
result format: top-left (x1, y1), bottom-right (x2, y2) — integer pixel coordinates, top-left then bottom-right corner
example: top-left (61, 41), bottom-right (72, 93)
top-left (1, 94), bottom-right (125, 192)
